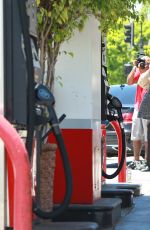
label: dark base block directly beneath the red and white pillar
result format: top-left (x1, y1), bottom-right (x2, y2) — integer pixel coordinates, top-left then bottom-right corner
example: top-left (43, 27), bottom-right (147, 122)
top-left (53, 198), bottom-right (122, 229)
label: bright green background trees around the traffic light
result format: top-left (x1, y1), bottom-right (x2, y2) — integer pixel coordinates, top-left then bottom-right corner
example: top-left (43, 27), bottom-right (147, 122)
top-left (107, 5), bottom-right (150, 84)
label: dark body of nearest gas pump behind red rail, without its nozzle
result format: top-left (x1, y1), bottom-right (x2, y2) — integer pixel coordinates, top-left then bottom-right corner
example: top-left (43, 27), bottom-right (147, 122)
top-left (3, 0), bottom-right (36, 226)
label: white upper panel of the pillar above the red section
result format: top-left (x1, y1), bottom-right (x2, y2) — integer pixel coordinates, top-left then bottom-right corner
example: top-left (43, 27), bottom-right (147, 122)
top-left (54, 17), bottom-right (101, 128)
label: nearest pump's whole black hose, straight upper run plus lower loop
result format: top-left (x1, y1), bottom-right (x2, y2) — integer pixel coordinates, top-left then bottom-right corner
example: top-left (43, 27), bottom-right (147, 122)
top-left (17, 0), bottom-right (72, 219)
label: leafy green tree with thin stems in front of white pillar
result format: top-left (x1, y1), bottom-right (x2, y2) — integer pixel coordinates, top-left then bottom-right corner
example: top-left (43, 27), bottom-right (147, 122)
top-left (36, 0), bottom-right (150, 87)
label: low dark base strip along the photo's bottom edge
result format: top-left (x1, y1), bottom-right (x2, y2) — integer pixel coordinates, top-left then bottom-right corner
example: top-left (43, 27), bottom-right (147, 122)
top-left (33, 222), bottom-right (100, 230)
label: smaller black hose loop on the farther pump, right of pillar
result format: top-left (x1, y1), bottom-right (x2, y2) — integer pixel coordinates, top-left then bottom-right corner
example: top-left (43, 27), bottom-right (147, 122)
top-left (102, 123), bottom-right (126, 179)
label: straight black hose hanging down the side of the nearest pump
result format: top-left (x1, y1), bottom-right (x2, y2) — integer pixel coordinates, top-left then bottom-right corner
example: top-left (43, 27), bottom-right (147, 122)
top-left (17, 0), bottom-right (35, 159)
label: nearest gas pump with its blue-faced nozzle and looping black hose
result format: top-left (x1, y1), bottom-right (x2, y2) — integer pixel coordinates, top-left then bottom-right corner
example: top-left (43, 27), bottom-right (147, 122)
top-left (4, 0), bottom-right (72, 226)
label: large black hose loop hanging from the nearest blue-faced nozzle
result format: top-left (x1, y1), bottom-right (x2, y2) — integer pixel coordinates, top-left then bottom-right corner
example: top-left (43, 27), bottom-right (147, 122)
top-left (33, 108), bottom-right (72, 219)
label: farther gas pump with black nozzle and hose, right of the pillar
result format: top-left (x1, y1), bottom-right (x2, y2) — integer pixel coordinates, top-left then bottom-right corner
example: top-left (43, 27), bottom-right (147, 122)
top-left (101, 36), bottom-right (126, 182)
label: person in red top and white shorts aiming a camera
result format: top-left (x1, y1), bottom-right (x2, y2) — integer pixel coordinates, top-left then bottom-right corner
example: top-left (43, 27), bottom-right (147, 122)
top-left (127, 55), bottom-right (149, 171)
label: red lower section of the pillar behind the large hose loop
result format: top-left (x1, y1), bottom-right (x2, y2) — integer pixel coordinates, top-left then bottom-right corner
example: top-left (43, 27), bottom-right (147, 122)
top-left (49, 129), bottom-right (101, 204)
